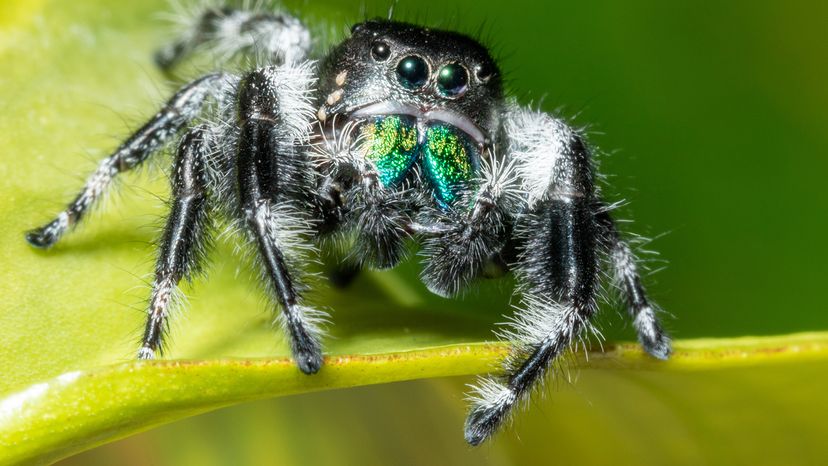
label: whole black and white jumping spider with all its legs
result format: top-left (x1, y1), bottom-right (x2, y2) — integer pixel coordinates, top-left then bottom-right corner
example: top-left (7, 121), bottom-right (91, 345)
top-left (26, 7), bottom-right (670, 445)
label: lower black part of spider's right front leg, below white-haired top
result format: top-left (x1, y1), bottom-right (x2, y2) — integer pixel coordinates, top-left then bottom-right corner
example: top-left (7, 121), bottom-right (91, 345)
top-left (465, 195), bottom-right (598, 445)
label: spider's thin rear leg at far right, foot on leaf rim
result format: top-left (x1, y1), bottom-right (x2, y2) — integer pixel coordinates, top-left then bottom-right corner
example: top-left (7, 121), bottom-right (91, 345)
top-left (596, 206), bottom-right (672, 359)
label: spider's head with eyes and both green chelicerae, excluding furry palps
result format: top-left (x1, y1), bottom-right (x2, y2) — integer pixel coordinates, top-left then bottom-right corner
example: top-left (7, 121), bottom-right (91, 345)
top-left (317, 21), bottom-right (503, 209)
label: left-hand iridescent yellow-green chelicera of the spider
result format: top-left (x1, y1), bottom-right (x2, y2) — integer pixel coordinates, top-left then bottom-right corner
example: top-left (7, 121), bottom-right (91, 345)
top-left (362, 115), bottom-right (417, 187)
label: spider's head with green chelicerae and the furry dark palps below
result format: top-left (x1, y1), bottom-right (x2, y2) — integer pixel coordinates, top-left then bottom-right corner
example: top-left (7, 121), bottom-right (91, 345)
top-left (315, 21), bottom-right (506, 278)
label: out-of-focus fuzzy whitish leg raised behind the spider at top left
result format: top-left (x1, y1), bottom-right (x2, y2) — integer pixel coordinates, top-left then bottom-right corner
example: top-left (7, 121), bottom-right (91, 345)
top-left (155, 6), bottom-right (311, 72)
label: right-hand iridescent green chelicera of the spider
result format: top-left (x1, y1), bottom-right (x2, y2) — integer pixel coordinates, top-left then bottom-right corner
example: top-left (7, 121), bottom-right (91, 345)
top-left (422, 123), bottom-right (475, 206)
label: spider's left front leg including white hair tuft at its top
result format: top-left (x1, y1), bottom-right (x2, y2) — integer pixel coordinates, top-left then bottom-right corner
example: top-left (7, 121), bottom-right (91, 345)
top-left (237, 65), bottom-right (323, 374)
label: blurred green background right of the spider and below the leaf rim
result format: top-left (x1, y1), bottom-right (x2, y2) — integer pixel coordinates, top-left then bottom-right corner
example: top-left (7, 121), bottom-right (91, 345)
top-left (4, 0), bottom-right (828, 465)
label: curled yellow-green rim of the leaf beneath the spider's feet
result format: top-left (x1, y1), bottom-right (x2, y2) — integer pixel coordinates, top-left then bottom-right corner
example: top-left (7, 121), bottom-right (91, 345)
top-left (0, 334), bottom-right (828, 463)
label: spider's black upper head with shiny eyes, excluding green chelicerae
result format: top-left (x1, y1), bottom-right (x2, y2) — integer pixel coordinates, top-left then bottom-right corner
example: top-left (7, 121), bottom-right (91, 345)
top-left (319, 20), bottom-right (503, 145)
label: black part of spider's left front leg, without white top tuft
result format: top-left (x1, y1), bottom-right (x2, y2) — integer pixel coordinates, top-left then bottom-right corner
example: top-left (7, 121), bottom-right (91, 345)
top-left (238, 70), bottom-right (323, 374)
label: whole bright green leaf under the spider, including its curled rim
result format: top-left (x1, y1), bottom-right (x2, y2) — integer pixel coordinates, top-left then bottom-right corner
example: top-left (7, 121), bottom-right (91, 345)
top-left (0, 0), bottom-right (828, 464)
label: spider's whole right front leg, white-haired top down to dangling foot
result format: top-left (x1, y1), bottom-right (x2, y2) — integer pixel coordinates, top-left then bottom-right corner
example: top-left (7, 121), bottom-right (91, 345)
top-left (466, 111), bottom-right (599, 445)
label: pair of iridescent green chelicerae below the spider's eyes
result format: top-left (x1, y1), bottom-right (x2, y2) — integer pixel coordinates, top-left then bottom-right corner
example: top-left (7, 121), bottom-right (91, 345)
top-left (361, 115), bottom-right (479, 208)
